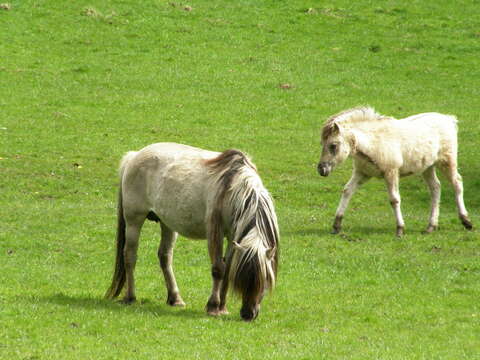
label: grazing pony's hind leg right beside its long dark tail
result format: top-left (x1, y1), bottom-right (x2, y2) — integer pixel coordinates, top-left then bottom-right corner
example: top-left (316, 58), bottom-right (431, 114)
top-left (123, 219), bottom-right (145, 304)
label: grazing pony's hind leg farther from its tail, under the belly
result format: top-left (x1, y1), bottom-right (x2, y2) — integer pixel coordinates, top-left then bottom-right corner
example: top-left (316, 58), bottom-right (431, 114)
top-left (158, 223), bottom-right (185, 306)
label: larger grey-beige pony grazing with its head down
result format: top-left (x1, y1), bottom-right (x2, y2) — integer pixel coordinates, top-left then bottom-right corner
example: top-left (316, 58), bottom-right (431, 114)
top-left (105, 143), bottom-right (279, 321)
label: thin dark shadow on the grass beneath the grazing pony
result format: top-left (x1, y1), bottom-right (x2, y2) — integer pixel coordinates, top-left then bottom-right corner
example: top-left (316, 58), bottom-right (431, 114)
top-left (31, 293), bottom-right (212, 319)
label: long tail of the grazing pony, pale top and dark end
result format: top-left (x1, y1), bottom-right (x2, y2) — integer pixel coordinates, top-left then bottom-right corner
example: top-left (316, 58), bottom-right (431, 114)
top-left (105, 151), bottom-right (136, 299)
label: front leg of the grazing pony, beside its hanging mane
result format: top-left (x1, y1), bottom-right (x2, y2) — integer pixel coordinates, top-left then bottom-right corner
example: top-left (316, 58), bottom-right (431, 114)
top-left (206, 229), bottom-right (228, 316)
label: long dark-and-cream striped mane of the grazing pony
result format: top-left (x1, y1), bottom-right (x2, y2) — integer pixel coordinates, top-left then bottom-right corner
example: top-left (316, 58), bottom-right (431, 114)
top-left (207, 150), bottom-right (279, 295)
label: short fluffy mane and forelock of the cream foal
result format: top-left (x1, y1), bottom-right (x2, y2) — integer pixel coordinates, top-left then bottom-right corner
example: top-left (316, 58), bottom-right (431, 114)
top-left (322, 106), bottom-right (391, 140)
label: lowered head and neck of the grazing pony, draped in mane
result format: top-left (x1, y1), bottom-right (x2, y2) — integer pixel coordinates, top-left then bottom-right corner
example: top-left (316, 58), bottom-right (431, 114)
top-left (228, 169), bottom-right (279, 321)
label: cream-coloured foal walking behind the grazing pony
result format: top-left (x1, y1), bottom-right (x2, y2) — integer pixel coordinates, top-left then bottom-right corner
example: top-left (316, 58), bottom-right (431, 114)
top-left (317, 107), bottom-right (473, 236)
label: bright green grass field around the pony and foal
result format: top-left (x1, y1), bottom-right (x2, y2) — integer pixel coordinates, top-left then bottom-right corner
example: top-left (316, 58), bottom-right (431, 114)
top-left (0, 0), bottom-right (480, 359)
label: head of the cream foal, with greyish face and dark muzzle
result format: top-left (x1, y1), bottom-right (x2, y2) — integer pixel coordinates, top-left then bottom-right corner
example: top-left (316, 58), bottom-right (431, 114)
top-left (317, 119), bottom-right (351, 176)
